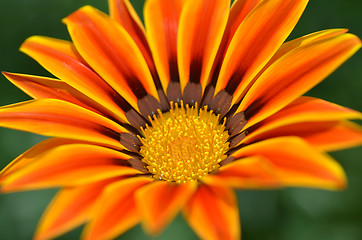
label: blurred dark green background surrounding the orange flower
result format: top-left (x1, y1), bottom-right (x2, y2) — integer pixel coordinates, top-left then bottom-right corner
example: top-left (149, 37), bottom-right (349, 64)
top-left (0, 0), bottom-right (362, 240)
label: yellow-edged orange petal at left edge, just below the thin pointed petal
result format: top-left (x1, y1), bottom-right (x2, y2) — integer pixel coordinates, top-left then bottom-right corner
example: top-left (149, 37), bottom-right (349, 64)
top-left (0, 99), bottom-right (126, 149)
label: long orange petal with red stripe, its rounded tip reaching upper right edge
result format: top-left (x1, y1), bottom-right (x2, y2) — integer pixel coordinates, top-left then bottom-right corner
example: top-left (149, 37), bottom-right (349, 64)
top-left (238, 34), bottom-right (361, 128)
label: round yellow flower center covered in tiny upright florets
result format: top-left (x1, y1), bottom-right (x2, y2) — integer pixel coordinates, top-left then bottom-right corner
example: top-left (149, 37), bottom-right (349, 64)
top-left (139, 102), bottom-right (229, 183)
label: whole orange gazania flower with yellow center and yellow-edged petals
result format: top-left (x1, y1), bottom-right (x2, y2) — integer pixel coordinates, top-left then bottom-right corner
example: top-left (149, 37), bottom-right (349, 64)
top-left (0, 0), bottom-right (362, 239)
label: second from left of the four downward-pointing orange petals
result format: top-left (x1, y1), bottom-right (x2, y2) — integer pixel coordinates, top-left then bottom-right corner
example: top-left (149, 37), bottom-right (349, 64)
top-left (83, 177), bottom-right (153, 240)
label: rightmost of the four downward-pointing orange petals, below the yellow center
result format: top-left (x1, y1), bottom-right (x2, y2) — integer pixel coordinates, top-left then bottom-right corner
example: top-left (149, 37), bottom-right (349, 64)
top-left (184, 185), bottom-right (240, 240)
